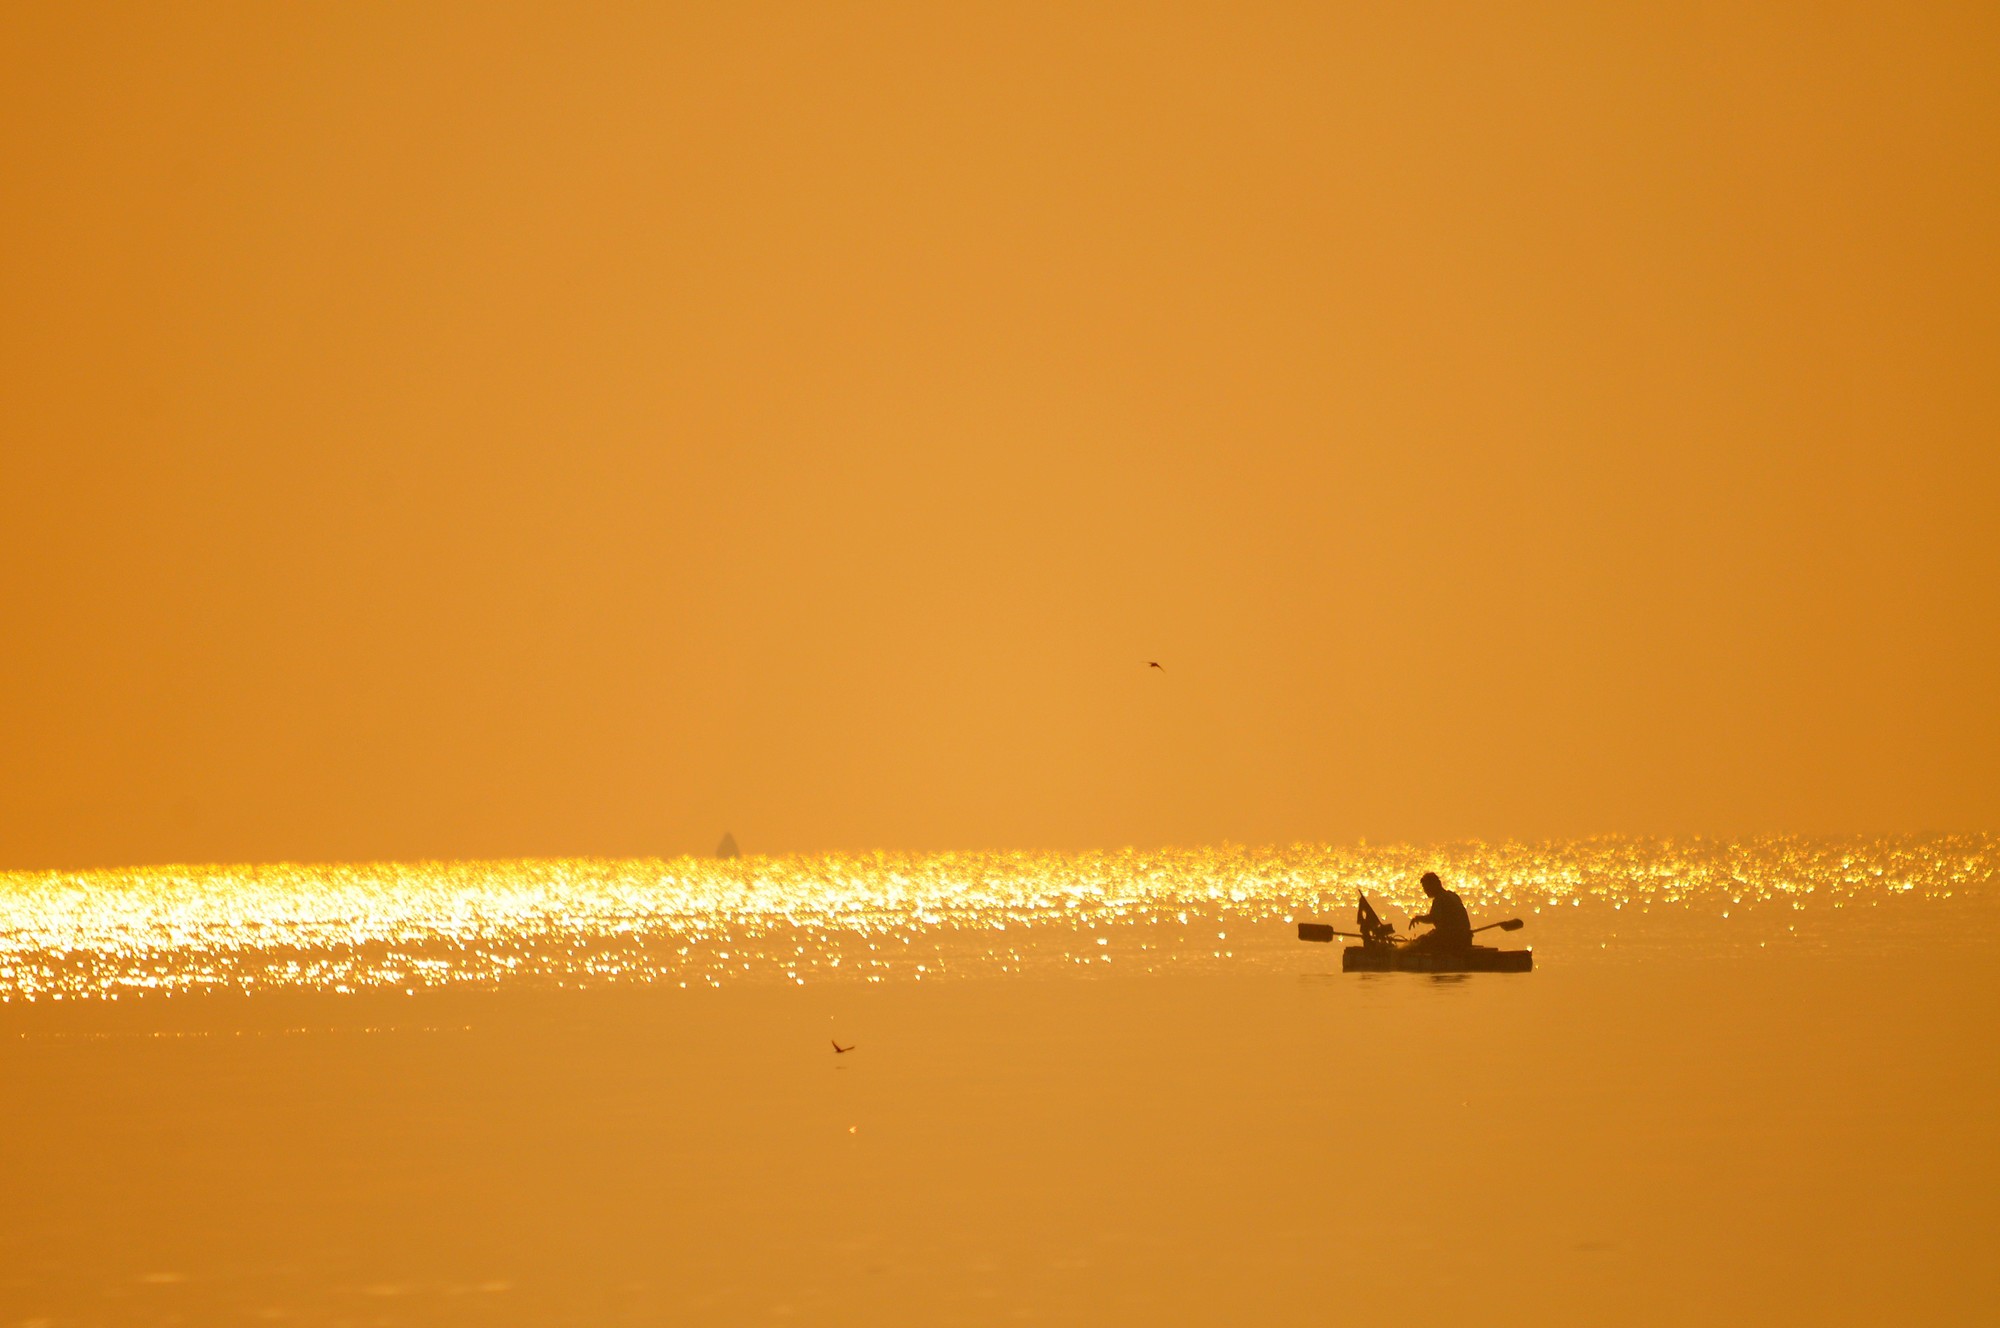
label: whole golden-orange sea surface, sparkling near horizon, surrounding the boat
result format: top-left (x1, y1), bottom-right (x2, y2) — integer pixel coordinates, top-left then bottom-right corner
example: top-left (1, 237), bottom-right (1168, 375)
top-left (0, 836), bottom-right (2000, 1324)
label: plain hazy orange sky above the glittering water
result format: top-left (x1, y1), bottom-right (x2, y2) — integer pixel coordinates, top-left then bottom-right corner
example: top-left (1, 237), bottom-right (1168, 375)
top-left (0, 4), bottom-right (2000, 868)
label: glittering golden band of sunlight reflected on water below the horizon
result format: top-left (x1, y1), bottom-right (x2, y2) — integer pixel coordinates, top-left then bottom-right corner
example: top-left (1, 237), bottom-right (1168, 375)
top-left (0, 836), bottom-right (2000, 1000)
